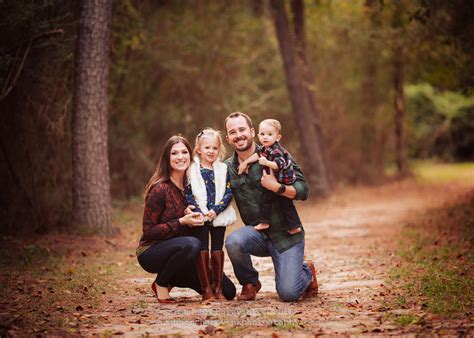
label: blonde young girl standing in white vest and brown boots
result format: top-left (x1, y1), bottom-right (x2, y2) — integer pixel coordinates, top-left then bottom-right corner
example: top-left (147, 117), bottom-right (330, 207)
top-left (185, 128), bottom-right (236, 301)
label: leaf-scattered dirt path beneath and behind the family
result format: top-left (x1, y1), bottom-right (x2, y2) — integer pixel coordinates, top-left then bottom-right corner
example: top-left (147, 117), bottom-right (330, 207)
top-left (80, 181), bottom-right (474, 336)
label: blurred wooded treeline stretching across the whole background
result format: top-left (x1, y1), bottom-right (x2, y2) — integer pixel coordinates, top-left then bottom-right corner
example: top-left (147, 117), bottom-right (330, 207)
top-left (0, 0), bottom-right (474, 233)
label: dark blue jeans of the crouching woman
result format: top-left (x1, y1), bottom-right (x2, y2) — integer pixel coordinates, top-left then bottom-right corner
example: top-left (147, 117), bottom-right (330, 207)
top-left (138, 237), bottom-right (235, 300)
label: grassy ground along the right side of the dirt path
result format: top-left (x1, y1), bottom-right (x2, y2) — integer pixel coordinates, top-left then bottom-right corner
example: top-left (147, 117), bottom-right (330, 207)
top-left (390, 193), bottom-right (474, 318)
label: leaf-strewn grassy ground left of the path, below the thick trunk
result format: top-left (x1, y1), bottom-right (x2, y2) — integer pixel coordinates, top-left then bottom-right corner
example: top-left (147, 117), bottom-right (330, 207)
top-left (0, 201), bottom-right (146, 336)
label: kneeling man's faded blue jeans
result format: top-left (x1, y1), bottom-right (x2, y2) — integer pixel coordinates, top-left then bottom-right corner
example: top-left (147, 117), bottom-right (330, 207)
top-left (225, 226), bottom-right (312, 302)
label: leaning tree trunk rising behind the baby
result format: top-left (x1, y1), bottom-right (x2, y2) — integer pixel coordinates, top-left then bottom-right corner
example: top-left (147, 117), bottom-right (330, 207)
top-left (271, 0), bottom-right (331, 196)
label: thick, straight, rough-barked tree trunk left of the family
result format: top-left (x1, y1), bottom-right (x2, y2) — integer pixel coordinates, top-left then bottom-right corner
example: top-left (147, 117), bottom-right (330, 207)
top-left (72, 0), bottom-right (114, 235)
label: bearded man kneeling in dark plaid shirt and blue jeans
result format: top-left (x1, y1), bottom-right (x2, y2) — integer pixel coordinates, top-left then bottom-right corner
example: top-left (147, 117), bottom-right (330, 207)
top-left (225, 112), bottom-right (318, 302)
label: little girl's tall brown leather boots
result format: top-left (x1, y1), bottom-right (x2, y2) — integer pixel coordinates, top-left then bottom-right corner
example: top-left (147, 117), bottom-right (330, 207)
top-left (197, 250), bottom-right (225, 301)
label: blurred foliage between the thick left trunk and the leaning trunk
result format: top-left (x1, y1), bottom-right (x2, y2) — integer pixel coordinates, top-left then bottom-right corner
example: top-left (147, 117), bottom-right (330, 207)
top-left (110, 0), bottom-right (295, 197)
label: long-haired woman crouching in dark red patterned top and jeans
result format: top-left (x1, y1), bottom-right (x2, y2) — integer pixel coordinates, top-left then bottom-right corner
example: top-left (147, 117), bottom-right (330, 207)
top-left (137, 136), bottom-right (235, 303)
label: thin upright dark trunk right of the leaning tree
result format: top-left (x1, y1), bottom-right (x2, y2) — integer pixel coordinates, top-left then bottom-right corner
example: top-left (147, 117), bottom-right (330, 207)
top-left (392, 1), bottom-right (408, 177)
